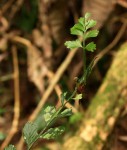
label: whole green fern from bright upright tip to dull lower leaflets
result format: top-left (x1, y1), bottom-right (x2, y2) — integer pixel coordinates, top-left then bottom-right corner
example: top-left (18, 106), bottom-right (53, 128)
top-left (5, 13), bottom-right (99, 150)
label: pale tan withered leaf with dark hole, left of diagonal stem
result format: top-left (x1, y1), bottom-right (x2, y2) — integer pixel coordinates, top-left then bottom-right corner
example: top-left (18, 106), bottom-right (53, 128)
top-left (27, 46), bottom-right (47, 93)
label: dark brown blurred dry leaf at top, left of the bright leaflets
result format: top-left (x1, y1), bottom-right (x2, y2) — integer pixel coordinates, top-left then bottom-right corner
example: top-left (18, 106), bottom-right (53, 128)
top-left (48, 0), bottom-right (68, 44)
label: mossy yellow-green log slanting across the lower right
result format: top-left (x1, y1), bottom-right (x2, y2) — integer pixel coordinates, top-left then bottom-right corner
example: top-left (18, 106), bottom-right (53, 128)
top-left (63, 43), bottom-right (127, 150)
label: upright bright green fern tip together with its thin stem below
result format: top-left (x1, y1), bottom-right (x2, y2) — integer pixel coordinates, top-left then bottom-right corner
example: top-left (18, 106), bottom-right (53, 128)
top-left (65, 13), bottom-right (99, 84)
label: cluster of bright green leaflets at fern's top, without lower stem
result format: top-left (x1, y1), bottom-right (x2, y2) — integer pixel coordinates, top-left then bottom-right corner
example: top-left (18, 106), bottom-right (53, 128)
top-left (65, 13), bottom-right (99, 52)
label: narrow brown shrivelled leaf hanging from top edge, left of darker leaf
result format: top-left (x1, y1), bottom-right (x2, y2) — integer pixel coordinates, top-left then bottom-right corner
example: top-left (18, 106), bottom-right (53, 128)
top-left (37, 0), bottom-right (52, 58)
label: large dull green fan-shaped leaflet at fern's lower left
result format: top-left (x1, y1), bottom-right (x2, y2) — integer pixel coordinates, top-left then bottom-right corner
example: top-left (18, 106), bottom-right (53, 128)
top-left (23, 122), bottom-right (38, 149)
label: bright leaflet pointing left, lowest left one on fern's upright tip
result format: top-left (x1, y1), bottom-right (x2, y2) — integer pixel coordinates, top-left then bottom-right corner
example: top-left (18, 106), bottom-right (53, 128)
top-left (65, 40), bottom-right (82, 49)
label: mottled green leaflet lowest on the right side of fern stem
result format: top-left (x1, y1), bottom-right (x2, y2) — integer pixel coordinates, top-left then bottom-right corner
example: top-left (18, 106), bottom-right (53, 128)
top-left (40, 126), bottom-right (65, 140)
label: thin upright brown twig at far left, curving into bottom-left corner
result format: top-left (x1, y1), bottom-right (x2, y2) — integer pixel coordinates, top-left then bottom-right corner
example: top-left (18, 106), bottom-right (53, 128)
top-left (1, 47), bottom-right (20, 150)
